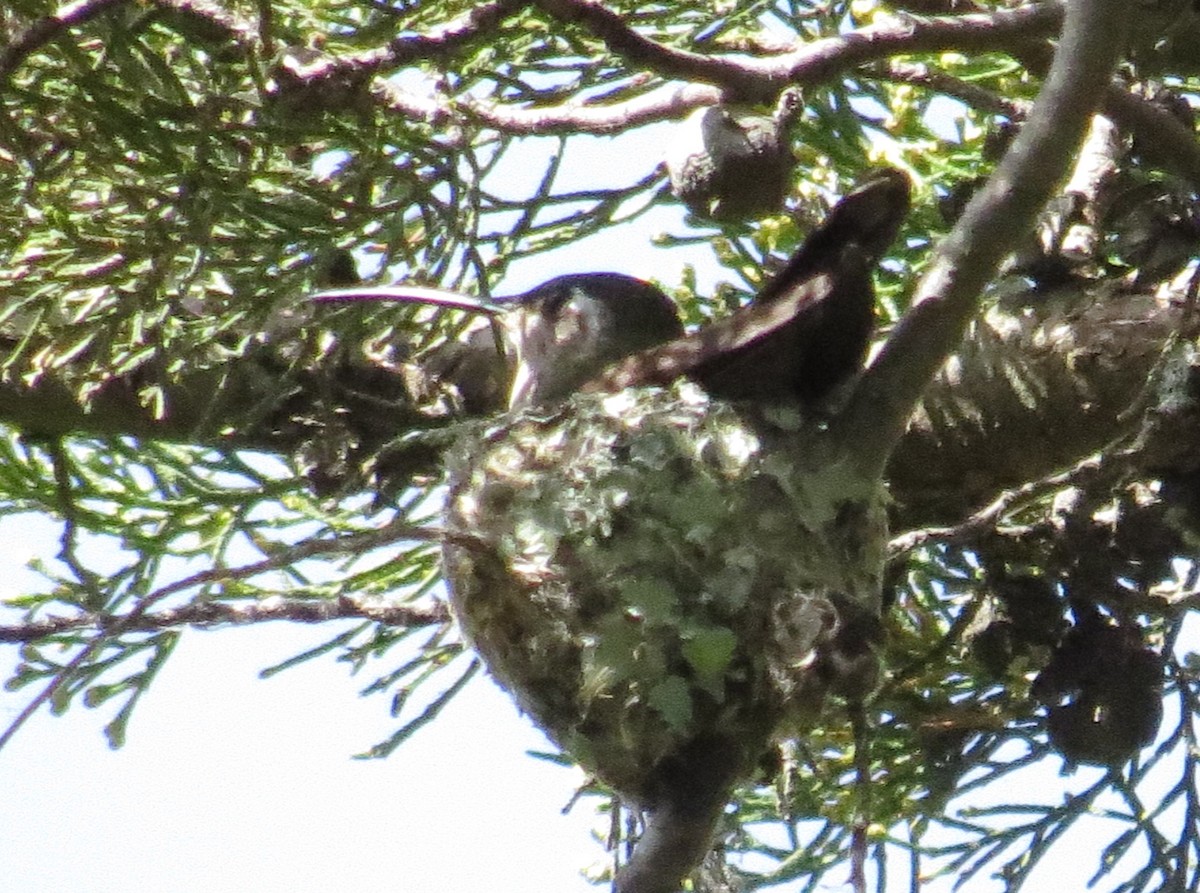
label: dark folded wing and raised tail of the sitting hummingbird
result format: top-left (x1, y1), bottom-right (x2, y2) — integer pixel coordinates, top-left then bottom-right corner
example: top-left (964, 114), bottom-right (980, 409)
top-left (583, 170), bottom-right (908, 403)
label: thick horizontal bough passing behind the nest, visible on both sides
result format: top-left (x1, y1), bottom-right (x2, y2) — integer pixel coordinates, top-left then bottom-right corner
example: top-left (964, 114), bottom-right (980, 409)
top-left (0, 283), bottom-right (1180, 535)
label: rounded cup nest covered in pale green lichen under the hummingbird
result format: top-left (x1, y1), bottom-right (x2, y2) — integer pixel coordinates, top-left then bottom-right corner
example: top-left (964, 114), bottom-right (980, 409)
top-left (446, 383), bottom-right (886, 805)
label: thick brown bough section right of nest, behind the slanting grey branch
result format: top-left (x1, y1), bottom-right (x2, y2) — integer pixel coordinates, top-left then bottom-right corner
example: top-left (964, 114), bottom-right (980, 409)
top-left (887, 286), bottom-right (1176, 529)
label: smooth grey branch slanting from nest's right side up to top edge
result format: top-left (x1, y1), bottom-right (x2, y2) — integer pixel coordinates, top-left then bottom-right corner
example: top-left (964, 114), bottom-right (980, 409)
top-left (844, 0), bottom-right (1128, 474)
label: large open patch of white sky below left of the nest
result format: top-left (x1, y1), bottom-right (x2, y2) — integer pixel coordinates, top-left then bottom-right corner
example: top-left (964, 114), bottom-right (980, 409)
top-left (0, 583), bottom-right (604, 893)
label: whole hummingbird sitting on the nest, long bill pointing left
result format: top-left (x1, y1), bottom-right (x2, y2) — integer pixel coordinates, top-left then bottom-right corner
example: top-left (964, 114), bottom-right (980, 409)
top-left (312, 169), bottom-right (910, 409)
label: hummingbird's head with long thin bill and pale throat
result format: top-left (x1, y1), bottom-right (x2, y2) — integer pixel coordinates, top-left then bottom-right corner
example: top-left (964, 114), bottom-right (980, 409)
top-left (312, 272), bottom-right (683, 408)
